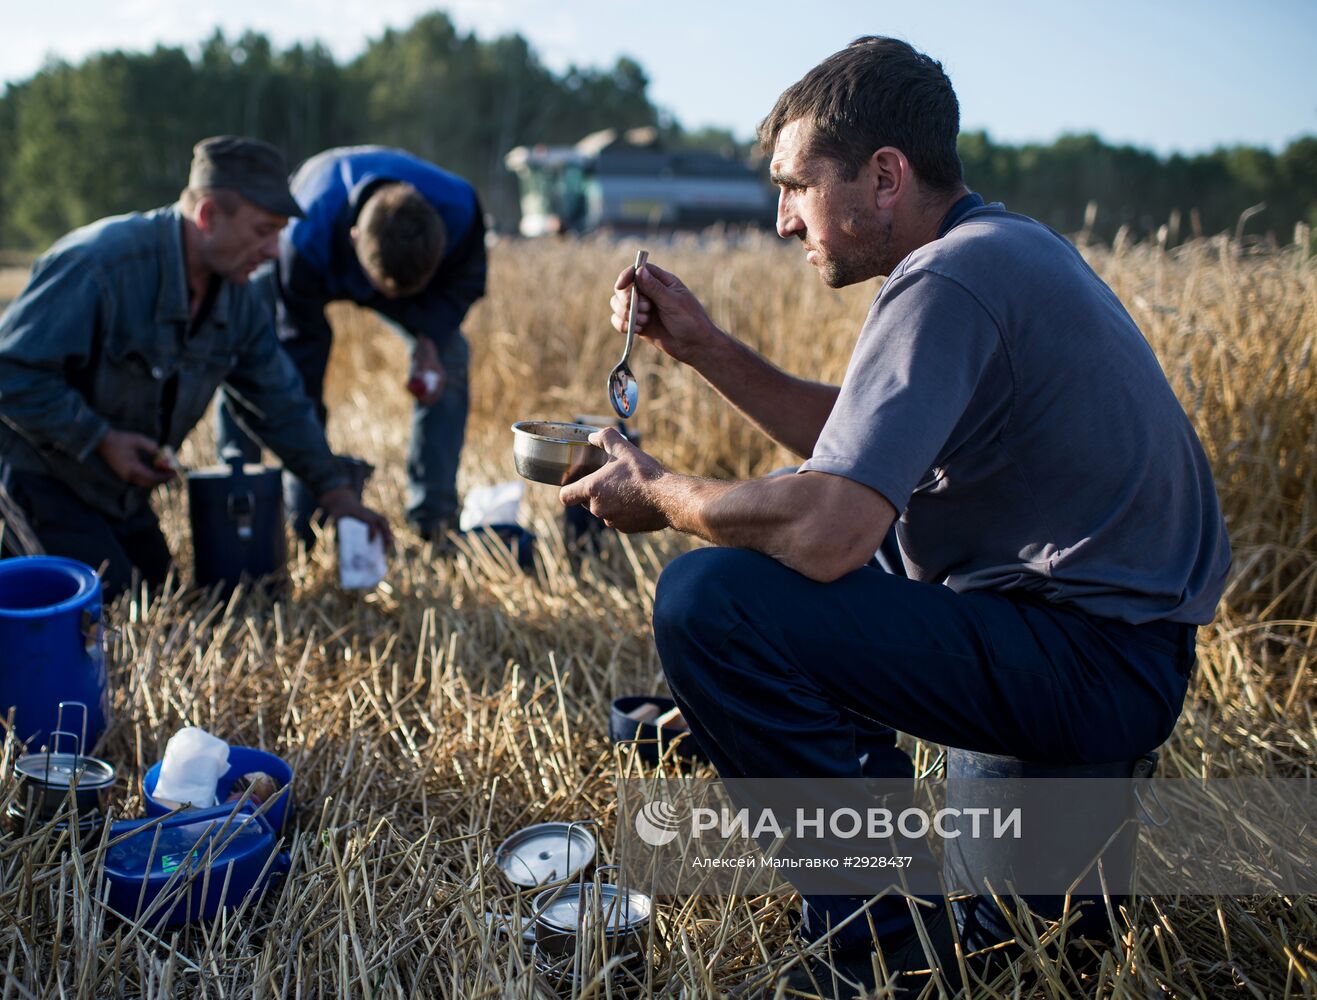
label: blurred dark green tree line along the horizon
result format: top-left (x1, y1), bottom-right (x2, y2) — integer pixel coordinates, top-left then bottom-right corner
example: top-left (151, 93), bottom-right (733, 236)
top-left (0, 12), bottom-right (1317, 249)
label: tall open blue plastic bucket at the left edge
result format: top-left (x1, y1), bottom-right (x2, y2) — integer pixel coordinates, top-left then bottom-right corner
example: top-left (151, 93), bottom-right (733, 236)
top-left (0, 556), bottom-right (109, 754)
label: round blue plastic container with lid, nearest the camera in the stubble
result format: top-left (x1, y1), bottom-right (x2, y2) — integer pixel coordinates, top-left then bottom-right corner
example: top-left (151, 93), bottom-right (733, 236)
top-left (105, 805), bottom-right (288, 928)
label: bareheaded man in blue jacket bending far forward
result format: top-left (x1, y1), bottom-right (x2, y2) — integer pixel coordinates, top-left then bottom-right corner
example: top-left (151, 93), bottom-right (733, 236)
top-left (220, 146), bottom-right (486, 540)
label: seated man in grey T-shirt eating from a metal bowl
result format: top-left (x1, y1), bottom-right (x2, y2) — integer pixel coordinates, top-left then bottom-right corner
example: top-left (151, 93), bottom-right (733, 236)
top-left (561, 37), bottom-right (1230, 989)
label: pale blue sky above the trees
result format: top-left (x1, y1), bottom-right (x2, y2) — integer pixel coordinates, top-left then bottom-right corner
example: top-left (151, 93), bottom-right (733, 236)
top-left (0, 0), bottom-right (1317, 153)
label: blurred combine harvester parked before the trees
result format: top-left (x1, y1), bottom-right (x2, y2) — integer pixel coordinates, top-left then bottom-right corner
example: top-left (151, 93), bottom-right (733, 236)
top-left (504, 128), bottom-right (777, 236)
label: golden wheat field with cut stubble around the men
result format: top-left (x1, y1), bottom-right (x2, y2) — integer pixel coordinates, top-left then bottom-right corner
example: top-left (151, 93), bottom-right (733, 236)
top-left (0, 237), bottom-right (1317, 1000)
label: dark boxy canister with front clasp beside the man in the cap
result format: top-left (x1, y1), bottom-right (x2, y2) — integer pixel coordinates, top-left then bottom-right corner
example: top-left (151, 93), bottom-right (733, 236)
top-left (187, 452), bottom-right (288, 594)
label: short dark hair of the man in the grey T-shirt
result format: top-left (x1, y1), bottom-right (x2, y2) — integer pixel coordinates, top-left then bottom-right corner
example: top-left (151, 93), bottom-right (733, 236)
top-left (759, 36), bottom-right (961, 191)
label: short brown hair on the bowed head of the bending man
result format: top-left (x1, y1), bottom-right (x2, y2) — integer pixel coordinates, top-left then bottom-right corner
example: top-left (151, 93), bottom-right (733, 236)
top-left (357, 183), bottom-right (448, 296)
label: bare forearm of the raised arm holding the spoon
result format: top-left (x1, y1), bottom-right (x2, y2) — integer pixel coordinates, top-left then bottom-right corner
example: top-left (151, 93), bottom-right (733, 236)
top-left (693, 333), bottom-right (840, 458)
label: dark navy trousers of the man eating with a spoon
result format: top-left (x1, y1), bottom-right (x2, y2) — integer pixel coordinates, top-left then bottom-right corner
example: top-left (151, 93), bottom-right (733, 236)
top-left (653, 548), bottom-right (1196, 949)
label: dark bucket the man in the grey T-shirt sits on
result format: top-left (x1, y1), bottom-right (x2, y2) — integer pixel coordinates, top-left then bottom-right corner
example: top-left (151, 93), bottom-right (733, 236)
top-left (943, 747), bottom-right (1156, 950)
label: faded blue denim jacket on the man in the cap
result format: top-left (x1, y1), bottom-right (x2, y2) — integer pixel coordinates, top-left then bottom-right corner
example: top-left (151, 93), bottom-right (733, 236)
top-left (0, 206), bottom-right (348, 518)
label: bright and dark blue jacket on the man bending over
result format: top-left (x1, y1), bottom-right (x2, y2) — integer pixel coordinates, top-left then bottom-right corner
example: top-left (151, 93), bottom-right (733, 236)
top-left (278, 146), bottom-right (486, 352)
